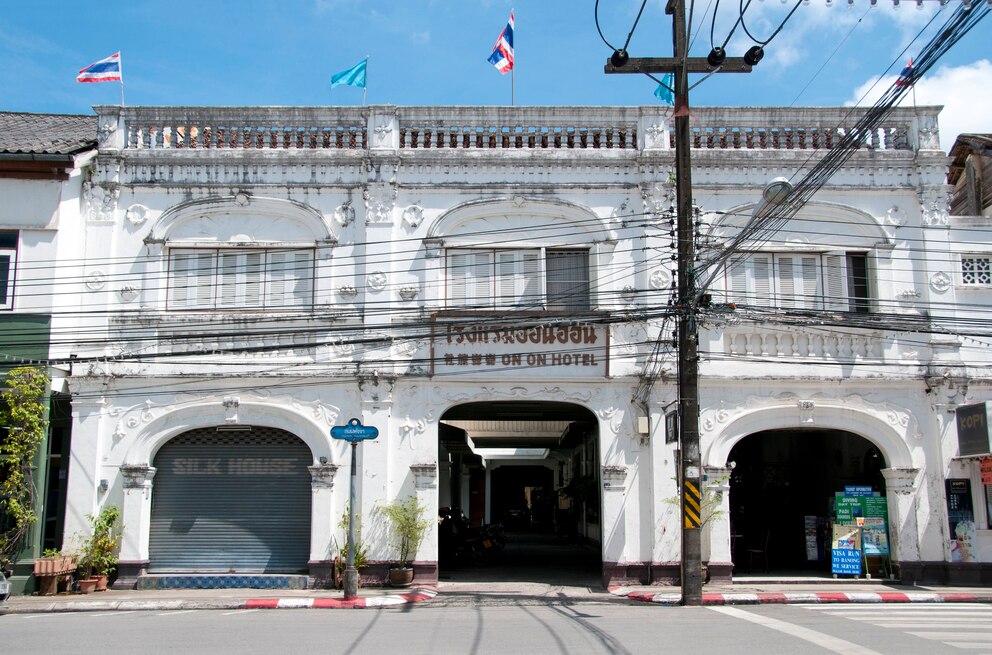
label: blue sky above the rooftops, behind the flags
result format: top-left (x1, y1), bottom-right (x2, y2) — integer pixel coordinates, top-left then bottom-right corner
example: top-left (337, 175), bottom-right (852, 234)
top-left (0, 0), bottom-right (992, 145)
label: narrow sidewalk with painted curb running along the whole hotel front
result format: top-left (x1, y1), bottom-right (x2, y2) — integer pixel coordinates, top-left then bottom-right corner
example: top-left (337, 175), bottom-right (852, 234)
top-left (0, 578), bottom-right (992, 614)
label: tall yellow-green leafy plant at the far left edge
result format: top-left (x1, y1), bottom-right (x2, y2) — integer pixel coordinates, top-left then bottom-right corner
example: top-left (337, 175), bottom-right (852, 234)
top-left (0, 367), bottom-right (48, 562)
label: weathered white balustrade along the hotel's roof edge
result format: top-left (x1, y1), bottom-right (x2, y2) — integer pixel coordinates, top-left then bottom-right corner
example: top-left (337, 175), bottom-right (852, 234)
top-left (97, 105), bottom-right (939, 151)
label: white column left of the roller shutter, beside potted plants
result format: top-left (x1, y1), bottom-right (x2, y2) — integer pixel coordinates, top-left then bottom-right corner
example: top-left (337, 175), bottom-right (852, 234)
top-left (114, 464), bottom-right (157, 589)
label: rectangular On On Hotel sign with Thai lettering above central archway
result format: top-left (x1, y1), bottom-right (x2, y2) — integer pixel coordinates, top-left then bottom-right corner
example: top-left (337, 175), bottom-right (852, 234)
top-left (431, 318), bottom-right (609, 377)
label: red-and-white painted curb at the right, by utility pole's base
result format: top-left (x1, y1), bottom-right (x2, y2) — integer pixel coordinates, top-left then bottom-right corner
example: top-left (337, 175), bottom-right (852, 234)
top-left (610, 587), bottom-right (992, 605)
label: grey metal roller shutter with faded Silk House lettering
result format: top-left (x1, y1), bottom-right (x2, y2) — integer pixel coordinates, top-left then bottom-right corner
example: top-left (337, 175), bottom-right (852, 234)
top-left (149, 427), bottom-right (313, 573)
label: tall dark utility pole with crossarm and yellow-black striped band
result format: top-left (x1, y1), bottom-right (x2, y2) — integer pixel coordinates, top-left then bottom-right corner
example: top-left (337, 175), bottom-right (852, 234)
top-left (605, 0), bottom-right (761, 606)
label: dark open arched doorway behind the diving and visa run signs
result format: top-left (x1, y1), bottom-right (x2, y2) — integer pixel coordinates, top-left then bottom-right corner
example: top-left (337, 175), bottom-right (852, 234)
top-left (727, 429), bottom-right (886, 575)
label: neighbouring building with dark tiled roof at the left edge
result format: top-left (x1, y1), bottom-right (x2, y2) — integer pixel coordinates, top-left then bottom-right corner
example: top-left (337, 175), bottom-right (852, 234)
top-left (0, 112), bottom-right (97, 592)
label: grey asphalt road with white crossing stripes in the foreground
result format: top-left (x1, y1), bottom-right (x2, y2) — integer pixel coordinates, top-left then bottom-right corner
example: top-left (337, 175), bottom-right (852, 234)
top-left (0, 603), bottom-right (992, 655)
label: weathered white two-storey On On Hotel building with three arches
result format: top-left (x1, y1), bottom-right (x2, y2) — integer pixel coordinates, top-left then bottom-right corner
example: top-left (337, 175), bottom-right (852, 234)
top-left (46, 106), bottom-right (992, 585)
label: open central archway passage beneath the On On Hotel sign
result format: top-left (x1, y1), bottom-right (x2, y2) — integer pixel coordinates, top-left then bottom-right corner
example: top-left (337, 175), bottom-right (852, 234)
top-left (438, 401), bottom-right (602, 584)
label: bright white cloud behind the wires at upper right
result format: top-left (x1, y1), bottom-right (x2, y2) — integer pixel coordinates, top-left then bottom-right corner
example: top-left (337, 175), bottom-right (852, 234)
top-left (844, 59), bottom-right (992, 151)
